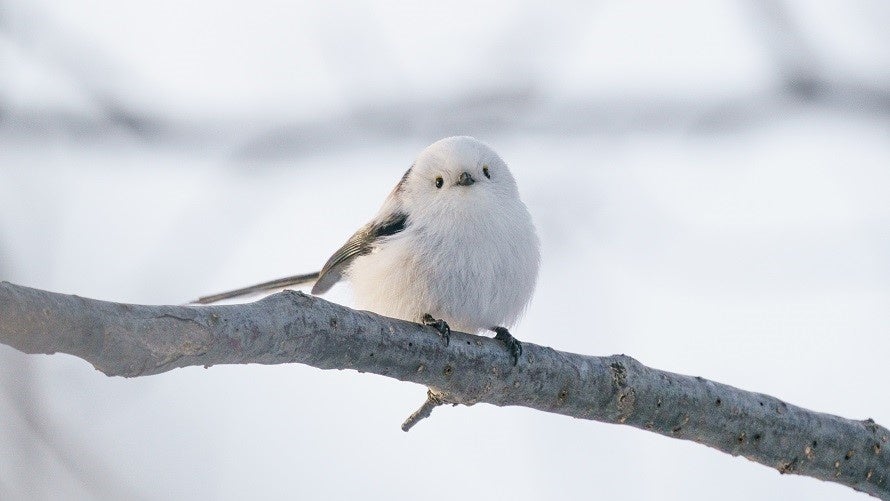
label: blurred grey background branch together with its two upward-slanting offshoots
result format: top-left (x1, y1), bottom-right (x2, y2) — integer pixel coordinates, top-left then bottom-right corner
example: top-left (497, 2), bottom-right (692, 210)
top-left (0, 0), bottom-right (890, 159)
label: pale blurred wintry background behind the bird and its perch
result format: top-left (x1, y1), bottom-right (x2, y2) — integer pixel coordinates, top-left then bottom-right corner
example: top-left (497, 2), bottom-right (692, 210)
top-left (0, 0), bottom-right (890, 501)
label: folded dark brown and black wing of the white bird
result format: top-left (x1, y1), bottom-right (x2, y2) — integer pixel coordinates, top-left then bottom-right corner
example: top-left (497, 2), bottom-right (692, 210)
top-left (312, 212), bottom-right (408, 294)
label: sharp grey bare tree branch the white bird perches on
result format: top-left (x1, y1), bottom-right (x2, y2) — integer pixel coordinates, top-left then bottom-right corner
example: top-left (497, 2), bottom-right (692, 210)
top-left (0, 282), bottom-right (890, 500)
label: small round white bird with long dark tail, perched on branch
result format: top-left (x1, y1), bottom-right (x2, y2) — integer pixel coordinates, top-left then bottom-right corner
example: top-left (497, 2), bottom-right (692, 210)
top-left (196, 136), bottom-right (540, 365)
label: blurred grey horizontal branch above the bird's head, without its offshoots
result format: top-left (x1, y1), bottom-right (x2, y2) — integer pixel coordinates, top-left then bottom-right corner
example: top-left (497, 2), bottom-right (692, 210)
top-left (0, 85), bottom-right (890, 160)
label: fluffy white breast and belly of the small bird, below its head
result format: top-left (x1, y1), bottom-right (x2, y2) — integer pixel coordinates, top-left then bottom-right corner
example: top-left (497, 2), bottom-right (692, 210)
top-left (347, 189), bottom-right (539, 332)
